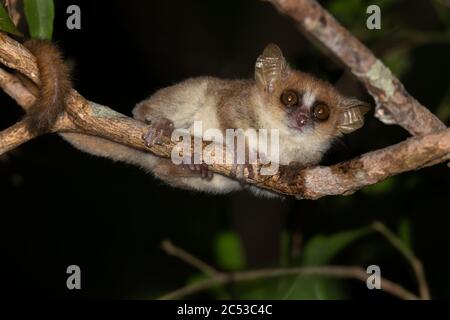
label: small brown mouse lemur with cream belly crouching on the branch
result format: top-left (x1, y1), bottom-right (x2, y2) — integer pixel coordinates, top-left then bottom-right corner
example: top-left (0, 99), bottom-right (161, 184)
top-left (22, 44), bottom-right (368, 195)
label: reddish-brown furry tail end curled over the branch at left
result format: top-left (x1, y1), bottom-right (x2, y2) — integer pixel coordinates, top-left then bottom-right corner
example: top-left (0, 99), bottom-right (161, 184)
top-left (24, 39), bottom-right (72, 133)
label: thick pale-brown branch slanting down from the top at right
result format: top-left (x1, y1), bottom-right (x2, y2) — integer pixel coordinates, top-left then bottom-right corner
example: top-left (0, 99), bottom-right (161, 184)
top-left (267, 0), bottom-right (446, 135)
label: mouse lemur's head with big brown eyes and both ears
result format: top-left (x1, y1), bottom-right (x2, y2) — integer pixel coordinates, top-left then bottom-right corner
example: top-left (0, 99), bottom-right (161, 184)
top-left (255, 44), bottom-right (369, 139)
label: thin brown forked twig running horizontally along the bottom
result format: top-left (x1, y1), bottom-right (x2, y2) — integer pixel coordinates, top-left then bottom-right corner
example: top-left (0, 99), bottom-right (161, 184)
top-left (159, 242), bottom-right (419, 300)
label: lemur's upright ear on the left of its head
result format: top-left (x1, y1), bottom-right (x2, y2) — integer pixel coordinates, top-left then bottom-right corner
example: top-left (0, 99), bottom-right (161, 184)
top-left (255, 43), bottom-right (286, 93)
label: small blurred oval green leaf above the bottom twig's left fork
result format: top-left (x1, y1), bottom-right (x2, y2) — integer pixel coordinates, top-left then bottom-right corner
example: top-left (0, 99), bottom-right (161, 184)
top-left (214, 231), bottom-right (245, 271)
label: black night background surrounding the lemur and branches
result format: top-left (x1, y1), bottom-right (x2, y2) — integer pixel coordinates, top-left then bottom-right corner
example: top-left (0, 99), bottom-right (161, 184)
top-left (0, 0), bottom-right (450, 299)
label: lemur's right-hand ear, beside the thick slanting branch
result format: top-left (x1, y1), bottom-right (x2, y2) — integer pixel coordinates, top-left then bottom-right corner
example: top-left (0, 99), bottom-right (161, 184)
top-left (337, 98), bottom-right (370, 133)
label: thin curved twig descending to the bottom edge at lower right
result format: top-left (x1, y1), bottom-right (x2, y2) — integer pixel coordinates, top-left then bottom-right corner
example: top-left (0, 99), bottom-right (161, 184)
top-left (372, 221), bottom-right (431, 300)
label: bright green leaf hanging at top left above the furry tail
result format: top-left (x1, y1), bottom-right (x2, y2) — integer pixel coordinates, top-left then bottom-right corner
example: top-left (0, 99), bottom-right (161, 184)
top-left (24, 0), bottom-right (55, 40)
